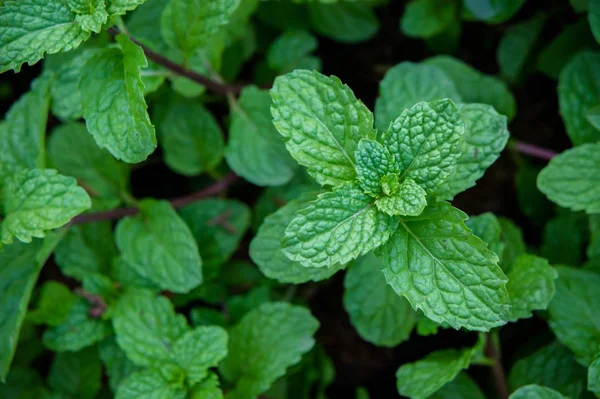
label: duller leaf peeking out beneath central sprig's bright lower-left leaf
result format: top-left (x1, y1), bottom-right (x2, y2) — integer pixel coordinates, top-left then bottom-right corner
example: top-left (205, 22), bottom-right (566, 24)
top-left (250, 195), bottom-right (345, 284)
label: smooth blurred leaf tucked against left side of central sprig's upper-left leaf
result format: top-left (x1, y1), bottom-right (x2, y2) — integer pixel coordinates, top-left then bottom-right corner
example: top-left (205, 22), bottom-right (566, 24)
top-left (225, 86), bottom-right (296, 186)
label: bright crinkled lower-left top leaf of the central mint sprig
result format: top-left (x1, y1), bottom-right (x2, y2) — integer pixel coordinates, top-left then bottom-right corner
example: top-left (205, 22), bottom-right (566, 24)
top-left (281, 184), bottom-right (398, 267)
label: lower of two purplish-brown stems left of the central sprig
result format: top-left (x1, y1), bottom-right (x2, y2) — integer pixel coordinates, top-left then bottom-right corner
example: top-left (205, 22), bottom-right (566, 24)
top-left (69, 172), bottom-right (239, 225)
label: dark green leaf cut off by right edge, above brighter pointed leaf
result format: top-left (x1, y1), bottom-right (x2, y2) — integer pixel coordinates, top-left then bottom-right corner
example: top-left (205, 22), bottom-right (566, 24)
top-left (558, 51), bottom-right (600, 145)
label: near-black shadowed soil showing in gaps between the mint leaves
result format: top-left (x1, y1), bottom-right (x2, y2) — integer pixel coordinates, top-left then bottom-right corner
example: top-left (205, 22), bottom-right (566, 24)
top-left (0, 0), bottom-right (577, 399)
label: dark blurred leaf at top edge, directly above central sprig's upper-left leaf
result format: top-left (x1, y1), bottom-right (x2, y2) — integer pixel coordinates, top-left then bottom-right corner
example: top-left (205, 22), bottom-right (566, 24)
top-left (308, 2), bottom-right (379, 43)
